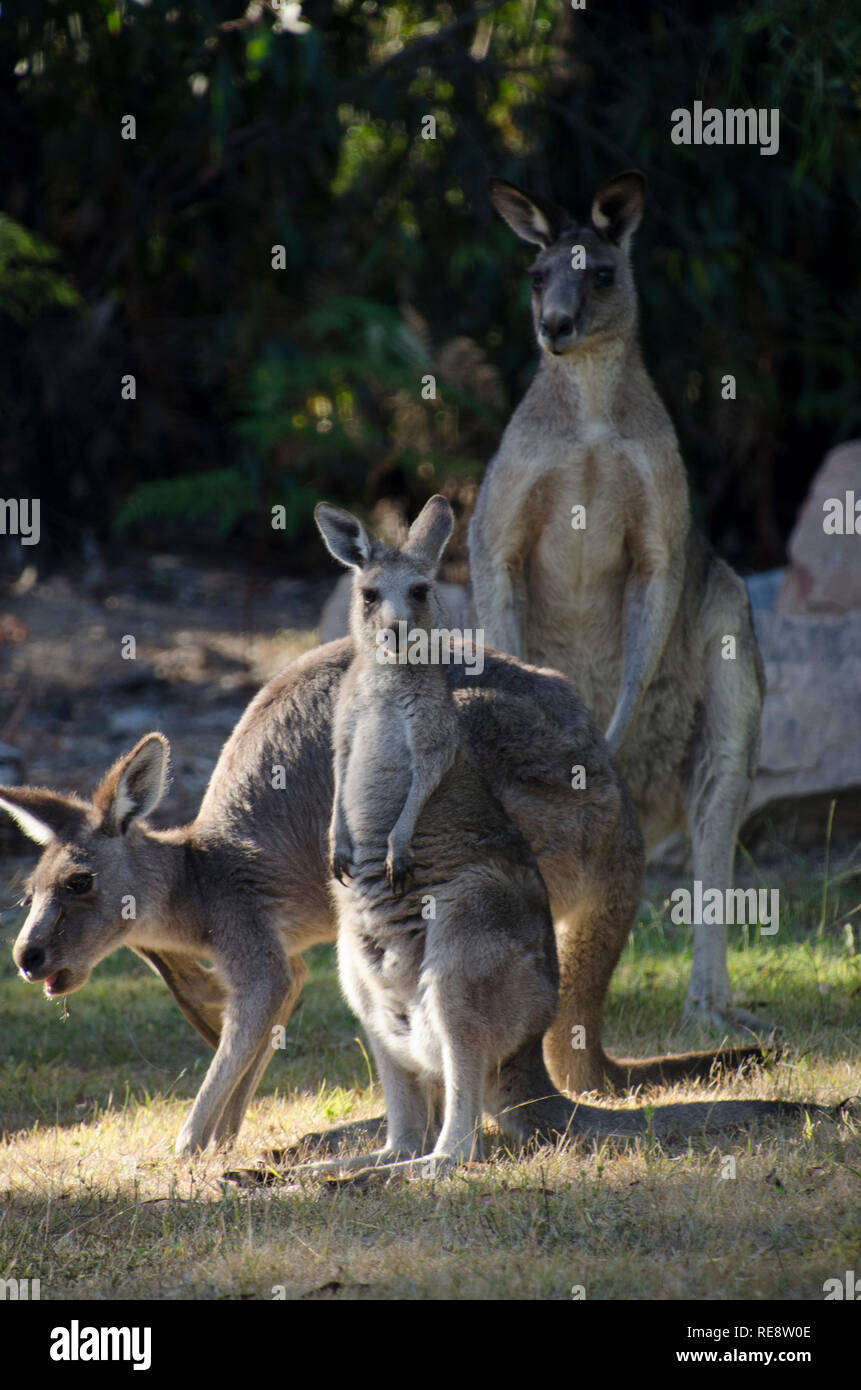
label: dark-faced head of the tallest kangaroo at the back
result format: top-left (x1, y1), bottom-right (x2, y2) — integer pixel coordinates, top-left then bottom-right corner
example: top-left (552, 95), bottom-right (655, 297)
top-left (490, 170), bottom-right (645, 357)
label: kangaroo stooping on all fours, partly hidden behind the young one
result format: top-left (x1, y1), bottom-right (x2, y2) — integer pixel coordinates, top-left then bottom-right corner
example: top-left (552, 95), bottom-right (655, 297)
top-left (0, 639), bottom-right (761, 1152)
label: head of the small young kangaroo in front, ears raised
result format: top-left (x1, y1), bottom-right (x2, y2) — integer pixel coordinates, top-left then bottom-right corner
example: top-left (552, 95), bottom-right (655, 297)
top-left (314, 496), bottom-right (455, 652)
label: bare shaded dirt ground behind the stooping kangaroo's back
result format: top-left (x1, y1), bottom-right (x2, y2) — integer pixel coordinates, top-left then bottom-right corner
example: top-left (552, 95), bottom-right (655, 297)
top-left (0, 555), bottom-right (331, 848)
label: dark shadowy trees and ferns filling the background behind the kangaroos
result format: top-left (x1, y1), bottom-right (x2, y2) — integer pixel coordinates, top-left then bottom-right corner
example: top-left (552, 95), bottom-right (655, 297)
top-left (0, 0), bottom-right (861, 569)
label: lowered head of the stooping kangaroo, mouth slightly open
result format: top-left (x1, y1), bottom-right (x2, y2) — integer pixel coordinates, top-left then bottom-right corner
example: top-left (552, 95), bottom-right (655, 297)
top-left (0, 734), bottom-right (170, 998)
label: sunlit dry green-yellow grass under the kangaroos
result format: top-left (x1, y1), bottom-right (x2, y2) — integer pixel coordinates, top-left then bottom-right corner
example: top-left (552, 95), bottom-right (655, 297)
top-left (0, 860), bottom-right (861, 1300)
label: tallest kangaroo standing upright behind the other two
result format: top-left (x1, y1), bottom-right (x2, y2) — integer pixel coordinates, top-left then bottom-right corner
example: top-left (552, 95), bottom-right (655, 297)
top-left (469, 171), bottom-right (765, 1027)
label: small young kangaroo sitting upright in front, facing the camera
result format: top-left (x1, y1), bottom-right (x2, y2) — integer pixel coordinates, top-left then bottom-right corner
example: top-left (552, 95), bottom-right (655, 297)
top-left (314, 496), bottom-right (572, 1170)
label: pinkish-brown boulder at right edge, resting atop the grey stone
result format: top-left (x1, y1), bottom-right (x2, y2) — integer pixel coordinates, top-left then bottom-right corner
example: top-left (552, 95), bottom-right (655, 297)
top-left (778, 439), bottom-right (861, 614)
